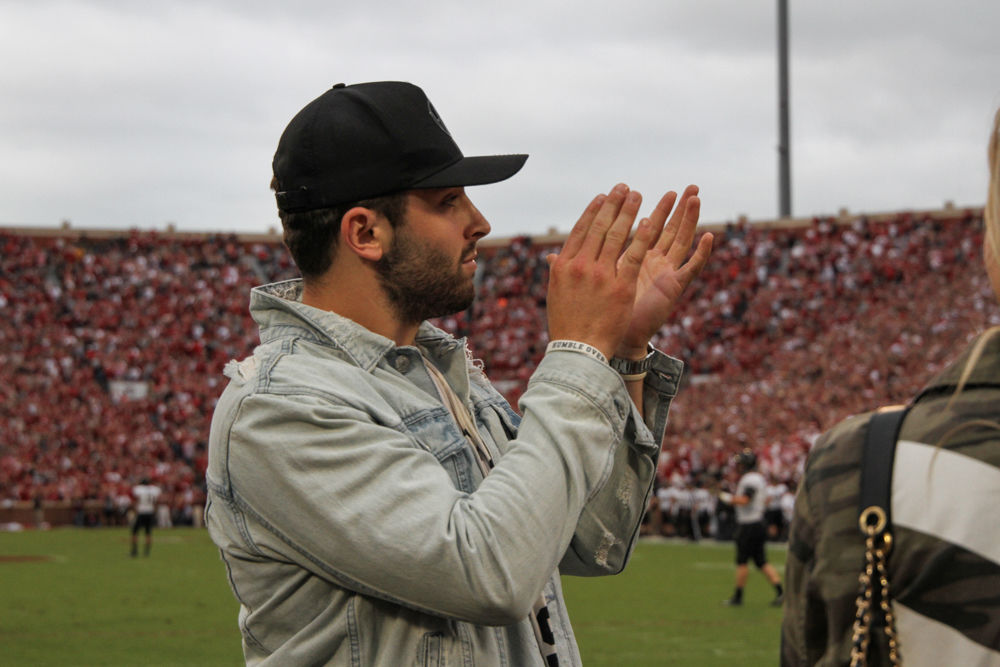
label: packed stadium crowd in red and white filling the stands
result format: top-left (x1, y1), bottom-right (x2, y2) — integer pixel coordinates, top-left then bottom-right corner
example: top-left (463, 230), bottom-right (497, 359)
top-left (0, 209), bottom-right (1000, 537)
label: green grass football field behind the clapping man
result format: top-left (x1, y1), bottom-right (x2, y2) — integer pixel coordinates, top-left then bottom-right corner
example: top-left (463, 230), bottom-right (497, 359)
top-left (0, 528), bottom-right (784, 667)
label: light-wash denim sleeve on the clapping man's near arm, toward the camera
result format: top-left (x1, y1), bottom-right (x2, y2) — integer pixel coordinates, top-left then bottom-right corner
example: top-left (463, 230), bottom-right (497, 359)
top-left (212, 352), bottom-right (655, 625)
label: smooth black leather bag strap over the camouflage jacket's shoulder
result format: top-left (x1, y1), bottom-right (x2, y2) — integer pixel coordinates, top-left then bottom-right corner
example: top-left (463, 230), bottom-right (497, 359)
top-left (858, 405), bottom-right (909, 534)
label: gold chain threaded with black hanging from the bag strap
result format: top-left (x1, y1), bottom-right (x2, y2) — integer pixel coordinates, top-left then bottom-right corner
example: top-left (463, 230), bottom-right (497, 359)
top-left (851, 506), bottom-right (903, 667)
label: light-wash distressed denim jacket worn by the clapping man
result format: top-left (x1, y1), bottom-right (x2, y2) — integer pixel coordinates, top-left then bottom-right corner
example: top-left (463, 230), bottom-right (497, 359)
top-left (206, 281), bottom-right (682, 667)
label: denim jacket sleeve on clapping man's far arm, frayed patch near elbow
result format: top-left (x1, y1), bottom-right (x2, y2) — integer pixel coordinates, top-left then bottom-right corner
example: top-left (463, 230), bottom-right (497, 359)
top-left (559, 352), bottom-right (683, 576)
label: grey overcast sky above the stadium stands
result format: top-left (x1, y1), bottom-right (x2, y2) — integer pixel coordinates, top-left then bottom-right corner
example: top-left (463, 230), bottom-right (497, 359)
top-left (0, 0), bottom-right (1000, 236)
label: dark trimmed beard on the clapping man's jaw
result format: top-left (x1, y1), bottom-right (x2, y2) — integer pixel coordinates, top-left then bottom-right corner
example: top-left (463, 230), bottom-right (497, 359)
top-left (375, 225), bottom-right (476, 324)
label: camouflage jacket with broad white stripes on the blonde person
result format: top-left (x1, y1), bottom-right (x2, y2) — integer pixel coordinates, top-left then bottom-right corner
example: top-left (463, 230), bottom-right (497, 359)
top-left (781, 331), bottom-right (1000, 666)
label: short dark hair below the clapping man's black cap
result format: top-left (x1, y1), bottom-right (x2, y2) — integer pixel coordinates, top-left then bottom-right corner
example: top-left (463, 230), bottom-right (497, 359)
top-left (271, 175), bottom-right (406, 280)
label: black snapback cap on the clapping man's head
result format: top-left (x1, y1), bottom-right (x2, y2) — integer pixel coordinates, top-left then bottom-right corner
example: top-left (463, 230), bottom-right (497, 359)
top-left (272, 81), bottom-right (528, 213)
